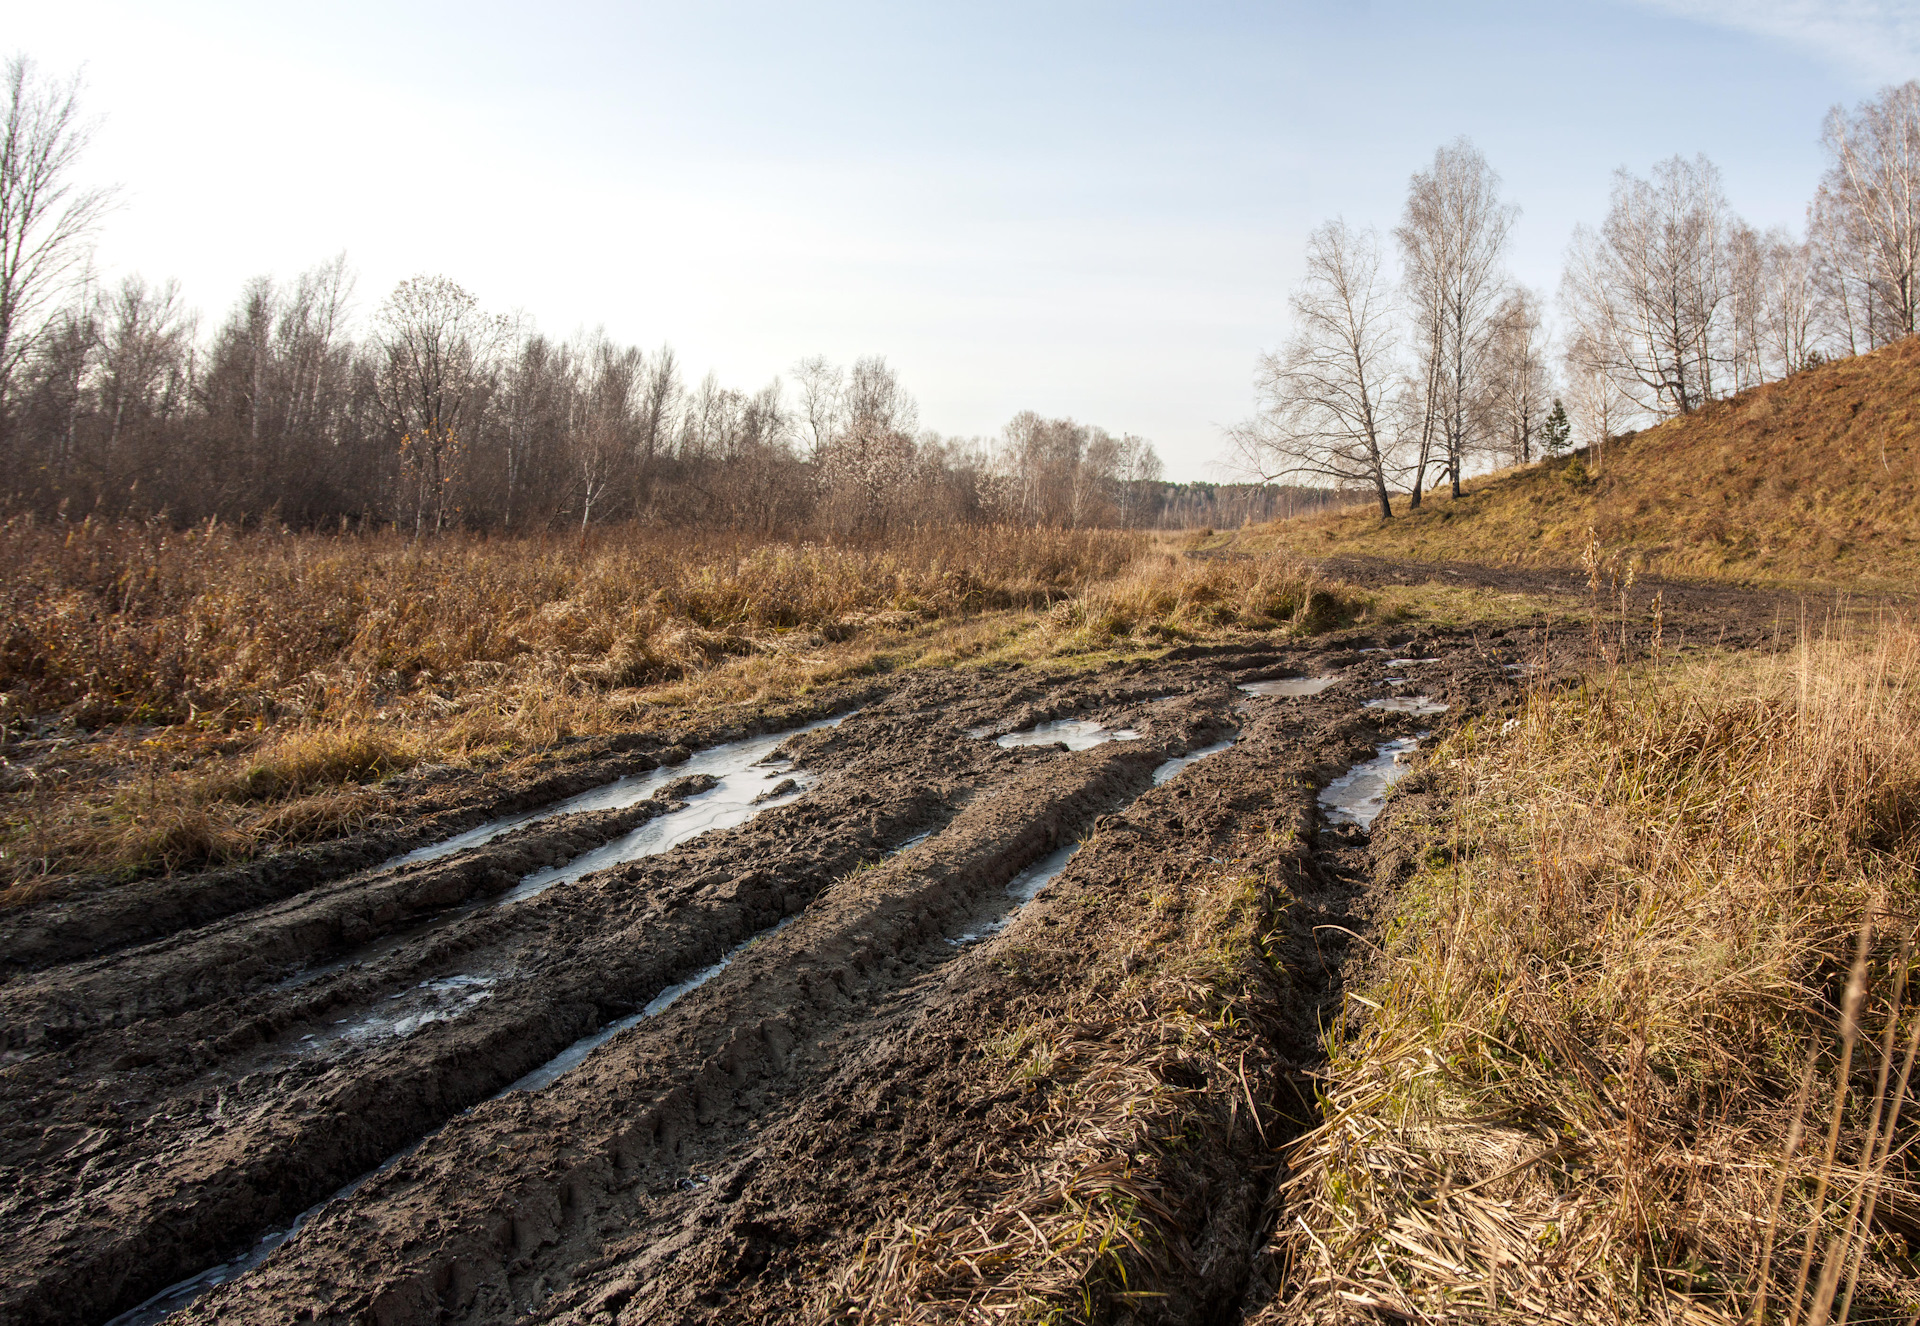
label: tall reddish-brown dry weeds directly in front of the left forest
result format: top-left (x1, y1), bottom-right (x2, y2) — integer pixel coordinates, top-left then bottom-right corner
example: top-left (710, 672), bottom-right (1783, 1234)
top-left (0, 518), bottom-right (1144, 725)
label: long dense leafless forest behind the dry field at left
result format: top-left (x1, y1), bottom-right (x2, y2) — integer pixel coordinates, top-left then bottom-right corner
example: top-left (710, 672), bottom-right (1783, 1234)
top-left (0, 59), bottom-right (1332, 535)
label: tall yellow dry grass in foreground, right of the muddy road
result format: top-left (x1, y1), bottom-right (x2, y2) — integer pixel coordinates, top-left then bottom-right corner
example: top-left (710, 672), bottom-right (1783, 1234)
top-left (1269, 622), bottom-right (1920, 1322)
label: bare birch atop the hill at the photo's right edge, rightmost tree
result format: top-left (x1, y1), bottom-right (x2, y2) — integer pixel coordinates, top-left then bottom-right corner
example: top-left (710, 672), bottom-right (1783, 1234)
top-left (1814, 81), bottom-right (1920, 349)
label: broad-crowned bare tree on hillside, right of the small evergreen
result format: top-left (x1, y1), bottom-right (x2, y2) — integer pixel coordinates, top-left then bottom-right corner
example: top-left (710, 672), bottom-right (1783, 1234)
top-left (1561, 157), bottom-right (1730, 416)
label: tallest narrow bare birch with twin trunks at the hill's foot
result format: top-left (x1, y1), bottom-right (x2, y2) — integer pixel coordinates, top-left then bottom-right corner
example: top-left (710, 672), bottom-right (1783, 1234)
top-left (1394, 138), bottom-right (1519, 507)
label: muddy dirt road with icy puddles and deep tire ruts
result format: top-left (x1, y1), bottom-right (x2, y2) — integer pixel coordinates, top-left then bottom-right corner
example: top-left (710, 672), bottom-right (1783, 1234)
top-left (0, 571), bottom-right (1778, 1326)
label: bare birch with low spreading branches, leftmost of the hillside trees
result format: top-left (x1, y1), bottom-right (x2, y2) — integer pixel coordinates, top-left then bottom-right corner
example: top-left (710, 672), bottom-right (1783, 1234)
top-left (1229, 221), bottom-right (1417, 520)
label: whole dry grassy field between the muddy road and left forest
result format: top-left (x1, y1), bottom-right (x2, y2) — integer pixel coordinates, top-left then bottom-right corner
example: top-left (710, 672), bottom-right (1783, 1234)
top-left (0, 522), bottom-right (1371, 906)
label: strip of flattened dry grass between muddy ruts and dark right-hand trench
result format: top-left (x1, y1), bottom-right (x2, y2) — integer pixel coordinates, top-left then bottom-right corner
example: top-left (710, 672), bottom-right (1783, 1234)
top-left (810, 864), bottom-right (1284, 1324)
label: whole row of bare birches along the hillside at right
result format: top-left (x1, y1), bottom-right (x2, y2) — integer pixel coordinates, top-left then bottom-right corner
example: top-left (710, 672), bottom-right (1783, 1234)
top-left (1233, 83), bottom-right (1920, 516)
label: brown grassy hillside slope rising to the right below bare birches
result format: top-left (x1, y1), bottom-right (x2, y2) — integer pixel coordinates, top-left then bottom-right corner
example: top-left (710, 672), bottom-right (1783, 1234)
top-left (1242, 338), bottom-right (1920, 583)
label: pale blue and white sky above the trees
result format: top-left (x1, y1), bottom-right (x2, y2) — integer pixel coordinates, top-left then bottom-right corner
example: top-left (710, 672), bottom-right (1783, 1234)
top-left (0, 0), bottom-right (1920, 480)
